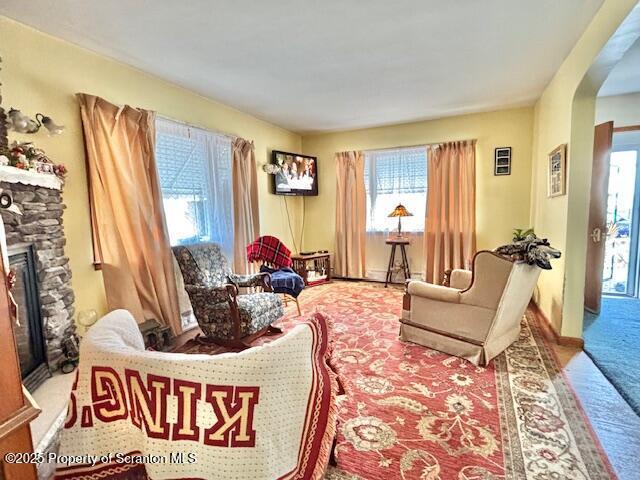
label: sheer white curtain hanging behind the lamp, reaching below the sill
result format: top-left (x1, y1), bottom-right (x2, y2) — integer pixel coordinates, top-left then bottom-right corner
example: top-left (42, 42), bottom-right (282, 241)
top-left (364, 147), bottom-right (427, 280)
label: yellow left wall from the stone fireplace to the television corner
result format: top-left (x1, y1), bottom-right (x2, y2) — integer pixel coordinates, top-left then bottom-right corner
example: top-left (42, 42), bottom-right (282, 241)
top-left (0, 17), bottom-right (302, 320)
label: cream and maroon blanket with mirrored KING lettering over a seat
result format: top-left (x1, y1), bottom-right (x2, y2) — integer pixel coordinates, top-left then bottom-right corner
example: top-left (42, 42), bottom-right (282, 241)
top-left (56, 310), bottom-right (336, 480)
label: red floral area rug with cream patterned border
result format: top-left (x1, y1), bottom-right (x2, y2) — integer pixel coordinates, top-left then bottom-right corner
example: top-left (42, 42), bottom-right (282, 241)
top-left (176, 282), bottom-right (615, 480)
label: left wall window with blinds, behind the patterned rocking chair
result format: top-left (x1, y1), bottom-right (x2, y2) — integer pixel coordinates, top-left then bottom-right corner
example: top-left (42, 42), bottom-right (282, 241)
top-left (156, 118), bottom-right (233, 259)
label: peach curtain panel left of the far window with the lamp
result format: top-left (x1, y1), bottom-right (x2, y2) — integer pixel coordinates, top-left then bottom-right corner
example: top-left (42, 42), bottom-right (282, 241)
top-left (335, 151), bottom-right (366, 278)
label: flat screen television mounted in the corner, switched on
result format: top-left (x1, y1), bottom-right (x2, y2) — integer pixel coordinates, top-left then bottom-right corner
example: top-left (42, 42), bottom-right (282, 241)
top-left (272, 150), bottom-right (318, 195)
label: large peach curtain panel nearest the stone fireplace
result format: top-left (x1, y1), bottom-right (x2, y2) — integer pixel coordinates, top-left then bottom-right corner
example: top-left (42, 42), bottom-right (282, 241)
top-left (77, 94), bottom-right (182, 334)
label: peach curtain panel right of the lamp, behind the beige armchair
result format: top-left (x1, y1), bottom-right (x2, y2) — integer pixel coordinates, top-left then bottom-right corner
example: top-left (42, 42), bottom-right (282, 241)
top-left (424, 140), bottom-right (476, 284)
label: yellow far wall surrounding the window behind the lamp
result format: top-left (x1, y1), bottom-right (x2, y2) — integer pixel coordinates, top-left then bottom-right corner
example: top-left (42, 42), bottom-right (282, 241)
top-left (302, 107), bottom-right (533, 271)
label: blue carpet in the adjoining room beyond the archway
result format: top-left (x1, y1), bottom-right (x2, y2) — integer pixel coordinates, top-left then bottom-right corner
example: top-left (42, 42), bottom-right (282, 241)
top-left (584, 297), bottom-right (640, 415)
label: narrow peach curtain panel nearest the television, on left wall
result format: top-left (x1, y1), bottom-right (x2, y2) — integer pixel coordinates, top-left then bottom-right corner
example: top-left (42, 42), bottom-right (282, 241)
top-left (231, 138), bottom-right (260, 273)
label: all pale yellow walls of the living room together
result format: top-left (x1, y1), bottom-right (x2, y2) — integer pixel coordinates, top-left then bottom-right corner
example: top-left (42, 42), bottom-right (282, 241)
top-left (6, 0), bottom-right (636, 336)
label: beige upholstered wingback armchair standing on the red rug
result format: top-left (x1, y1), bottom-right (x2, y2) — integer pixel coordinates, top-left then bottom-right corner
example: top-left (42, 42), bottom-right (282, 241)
top-left (400, 251), bottom-right (540, 366)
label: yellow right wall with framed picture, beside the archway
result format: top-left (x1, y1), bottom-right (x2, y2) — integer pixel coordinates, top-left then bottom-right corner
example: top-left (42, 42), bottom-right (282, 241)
top-left (531, 0), bottom-right (637, 337)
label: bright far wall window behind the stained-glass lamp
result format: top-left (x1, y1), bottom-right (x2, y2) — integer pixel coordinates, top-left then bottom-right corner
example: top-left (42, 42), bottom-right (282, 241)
top-left (364, 147), bottom-right (427, 232)
